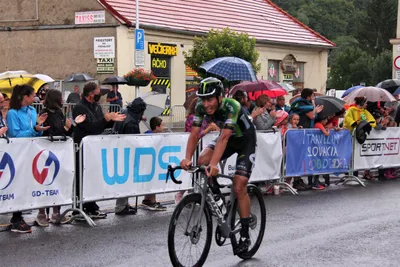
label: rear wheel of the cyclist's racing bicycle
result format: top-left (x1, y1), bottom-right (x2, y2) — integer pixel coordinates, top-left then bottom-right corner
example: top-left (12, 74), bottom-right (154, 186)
top-left (231, 185), bottom-right (266, 259)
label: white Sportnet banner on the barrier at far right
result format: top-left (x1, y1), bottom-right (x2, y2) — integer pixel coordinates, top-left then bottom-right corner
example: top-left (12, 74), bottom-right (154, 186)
top-left (353, 127), bottom-right (400, 170)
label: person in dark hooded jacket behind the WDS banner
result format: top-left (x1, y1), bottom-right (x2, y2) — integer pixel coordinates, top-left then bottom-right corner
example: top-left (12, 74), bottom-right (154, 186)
top-left (115, 97), bottom-right (147, 215)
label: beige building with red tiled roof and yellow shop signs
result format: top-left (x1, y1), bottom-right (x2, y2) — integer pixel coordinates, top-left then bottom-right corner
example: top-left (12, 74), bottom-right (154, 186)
top-left (0, 0), bottom-right (335, 113)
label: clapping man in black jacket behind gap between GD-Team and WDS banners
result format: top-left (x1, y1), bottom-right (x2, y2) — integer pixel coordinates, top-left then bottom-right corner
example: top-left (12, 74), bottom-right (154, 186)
top-left (72, 82), bottom-right (126, 219)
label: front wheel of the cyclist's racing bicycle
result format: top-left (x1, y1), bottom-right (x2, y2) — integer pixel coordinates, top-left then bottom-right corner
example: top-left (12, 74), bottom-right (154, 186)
top-left (168, 194), bottom-right (212, 267)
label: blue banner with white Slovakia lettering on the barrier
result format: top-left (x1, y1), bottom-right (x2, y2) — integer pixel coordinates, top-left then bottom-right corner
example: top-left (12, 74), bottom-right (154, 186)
top-left (286, 129), bottom-right (352, 176)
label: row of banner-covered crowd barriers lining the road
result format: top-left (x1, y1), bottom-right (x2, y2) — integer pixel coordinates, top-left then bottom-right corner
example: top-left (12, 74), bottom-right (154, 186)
top-left (0, 128), bottom-right (400, 225)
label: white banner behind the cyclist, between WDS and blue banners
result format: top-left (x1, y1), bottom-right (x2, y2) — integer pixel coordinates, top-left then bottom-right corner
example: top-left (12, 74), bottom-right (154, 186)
top-left (203, 132), bottom-right (283, 183)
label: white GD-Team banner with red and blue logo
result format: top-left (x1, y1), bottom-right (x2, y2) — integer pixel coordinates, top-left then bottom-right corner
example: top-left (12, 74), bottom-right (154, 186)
top-left (0, 138), bottom-right (75, 213)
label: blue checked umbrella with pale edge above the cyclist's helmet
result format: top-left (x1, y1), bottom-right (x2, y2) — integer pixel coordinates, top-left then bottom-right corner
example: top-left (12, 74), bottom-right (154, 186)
top-left (200, 57), bottom-right (257, 82)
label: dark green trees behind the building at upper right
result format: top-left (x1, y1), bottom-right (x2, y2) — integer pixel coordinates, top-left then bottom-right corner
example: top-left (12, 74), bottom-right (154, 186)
top-left (272, 0), bottom-right (398, 89)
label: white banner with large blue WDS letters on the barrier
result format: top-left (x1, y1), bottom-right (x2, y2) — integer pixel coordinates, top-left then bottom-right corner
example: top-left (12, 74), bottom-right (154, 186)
top-left (83, 134), bottom-right (192, 202)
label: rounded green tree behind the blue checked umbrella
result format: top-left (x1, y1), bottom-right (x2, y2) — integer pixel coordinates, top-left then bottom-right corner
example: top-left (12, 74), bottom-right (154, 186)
top-left (183, 28), bottom-right (261, 77)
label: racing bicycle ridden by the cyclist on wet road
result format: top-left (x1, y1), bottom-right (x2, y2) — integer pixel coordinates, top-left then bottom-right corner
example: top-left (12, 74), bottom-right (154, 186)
top-left (166, 165), bottom-right (266, 267)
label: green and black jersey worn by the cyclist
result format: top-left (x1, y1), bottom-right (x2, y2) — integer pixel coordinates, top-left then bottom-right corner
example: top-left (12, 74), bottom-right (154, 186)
top-left (192, 98), bottom-right (255, 138)
